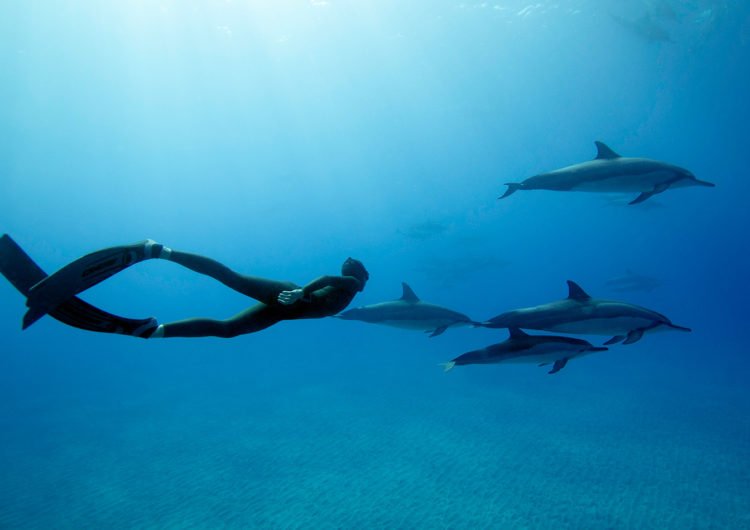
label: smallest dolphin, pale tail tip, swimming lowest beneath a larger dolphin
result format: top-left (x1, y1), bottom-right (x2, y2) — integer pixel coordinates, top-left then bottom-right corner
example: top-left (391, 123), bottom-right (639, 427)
top-left (443, 328), bottom-right (607, 374)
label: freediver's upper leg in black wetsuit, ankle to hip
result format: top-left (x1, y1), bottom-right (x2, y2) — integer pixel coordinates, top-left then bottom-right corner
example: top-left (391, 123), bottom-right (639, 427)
top-left (167, 250), bottom-right (299, 305)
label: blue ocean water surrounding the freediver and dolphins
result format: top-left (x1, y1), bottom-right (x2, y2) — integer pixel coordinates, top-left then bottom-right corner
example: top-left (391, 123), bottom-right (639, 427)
top-left (0, 0), bottom-right (750, 529)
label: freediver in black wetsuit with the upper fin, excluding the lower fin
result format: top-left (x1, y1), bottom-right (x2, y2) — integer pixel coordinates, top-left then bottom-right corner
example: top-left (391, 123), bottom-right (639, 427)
top-left (16, 240), bottom-right (370, 338)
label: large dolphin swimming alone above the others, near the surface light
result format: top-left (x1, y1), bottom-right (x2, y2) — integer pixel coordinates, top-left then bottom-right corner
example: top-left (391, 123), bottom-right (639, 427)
top-left (499, 142), bottom-right (715, 204)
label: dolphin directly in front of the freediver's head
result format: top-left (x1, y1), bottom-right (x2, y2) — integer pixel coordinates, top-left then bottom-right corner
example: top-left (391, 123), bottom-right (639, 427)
top-left (336, 283), bottom-right (479, 337)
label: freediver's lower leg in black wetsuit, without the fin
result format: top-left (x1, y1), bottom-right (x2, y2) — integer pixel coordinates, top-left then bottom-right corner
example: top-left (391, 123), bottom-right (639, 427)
top-left (144, 304), bottom-right (282, 338)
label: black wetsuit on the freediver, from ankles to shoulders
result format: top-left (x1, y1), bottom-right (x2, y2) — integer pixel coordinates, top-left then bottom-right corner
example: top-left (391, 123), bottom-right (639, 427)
top-left (157, 250), bottom-right (364, 338)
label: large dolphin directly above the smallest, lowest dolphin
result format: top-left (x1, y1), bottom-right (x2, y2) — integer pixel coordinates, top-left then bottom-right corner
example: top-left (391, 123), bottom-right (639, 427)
top-left (482, 280), bottom-right (692, 345)
